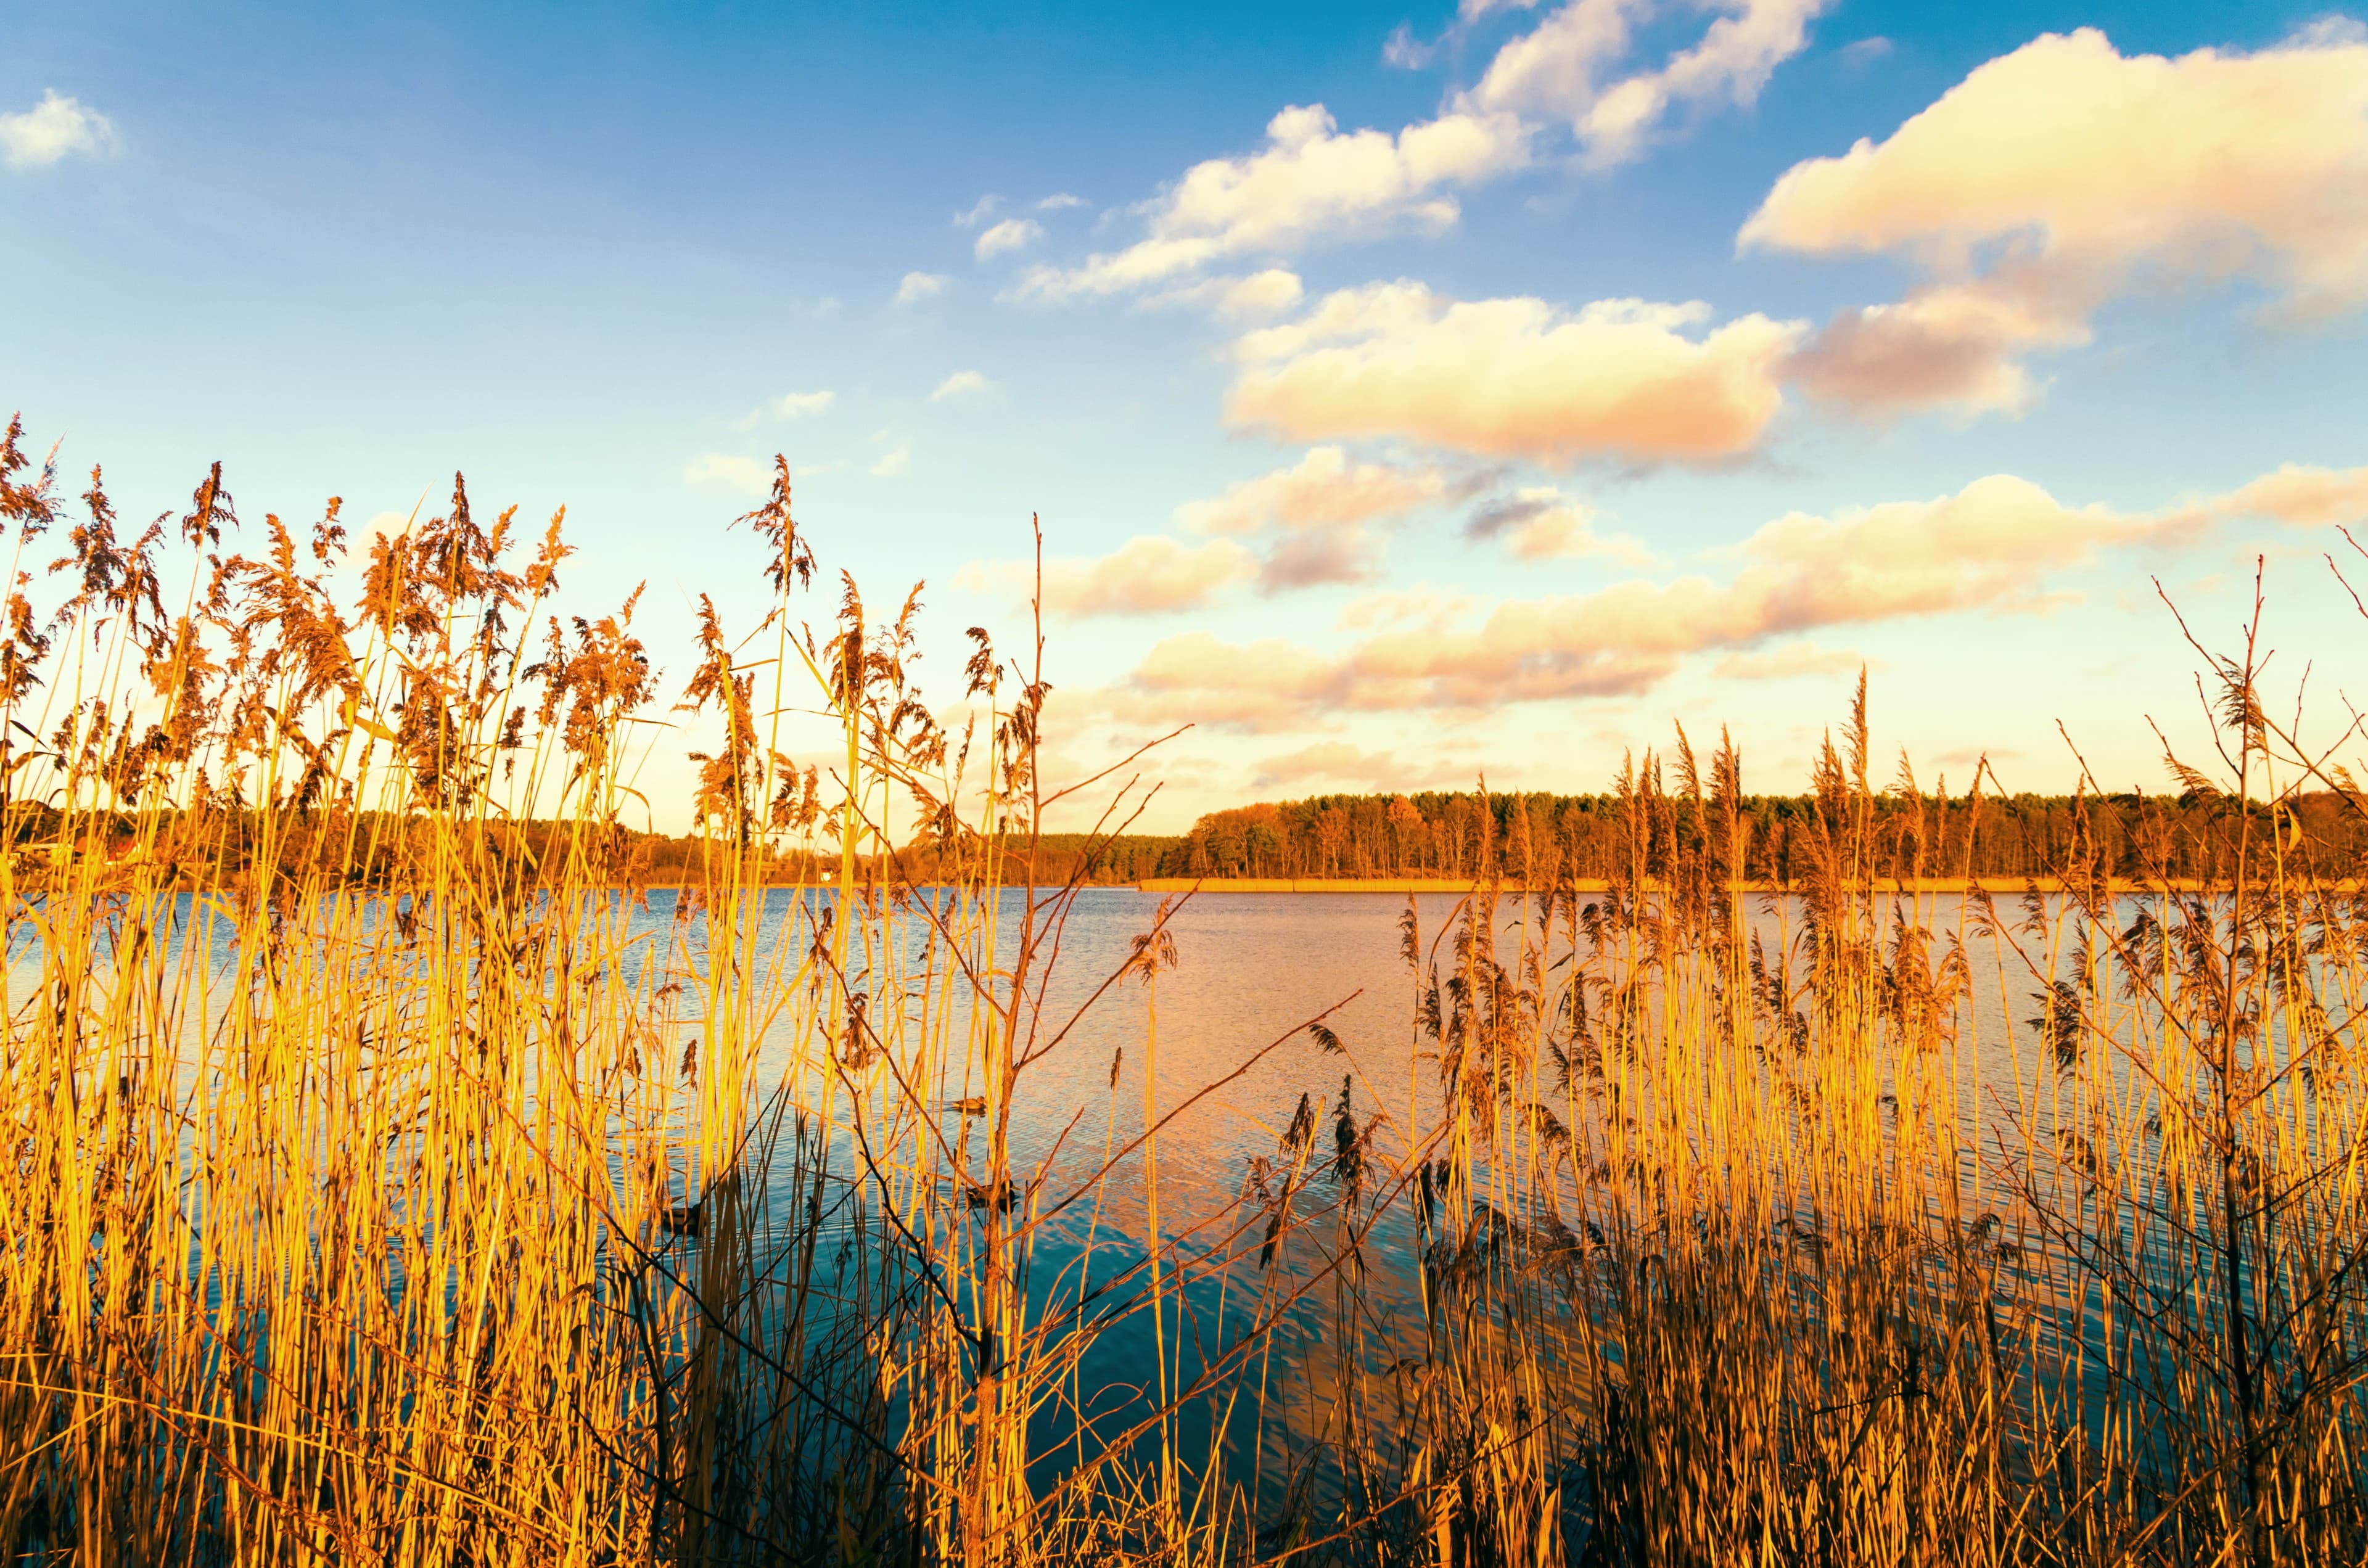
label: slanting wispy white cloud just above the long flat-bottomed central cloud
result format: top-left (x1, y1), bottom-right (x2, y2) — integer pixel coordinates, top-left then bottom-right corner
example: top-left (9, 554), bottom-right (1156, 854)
top-left (1021, 104), bottom-right (1527, 298)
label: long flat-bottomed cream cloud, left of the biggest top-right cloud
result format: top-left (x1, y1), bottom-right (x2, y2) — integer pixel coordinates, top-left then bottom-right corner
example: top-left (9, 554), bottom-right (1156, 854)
top-left (1224, 282), bottom-right (1804, 467)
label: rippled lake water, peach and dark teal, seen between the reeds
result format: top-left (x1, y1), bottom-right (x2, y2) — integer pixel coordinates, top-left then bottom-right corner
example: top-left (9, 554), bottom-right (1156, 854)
top-left (9, 889), bottom-right (2273, 1516)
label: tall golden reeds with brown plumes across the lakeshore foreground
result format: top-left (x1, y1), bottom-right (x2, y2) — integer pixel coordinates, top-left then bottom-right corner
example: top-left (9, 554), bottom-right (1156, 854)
top-left (0, 424), bottom-right (2368, 1568)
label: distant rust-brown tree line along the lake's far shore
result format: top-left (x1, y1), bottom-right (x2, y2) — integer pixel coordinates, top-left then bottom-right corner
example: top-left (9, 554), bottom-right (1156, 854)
top-left (28, 786), bottom-right (2368, 886)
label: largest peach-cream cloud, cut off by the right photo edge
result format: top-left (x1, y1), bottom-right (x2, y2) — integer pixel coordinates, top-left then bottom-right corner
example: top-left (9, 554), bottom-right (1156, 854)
top-left (1738, 28), bottom-right (2368, 412)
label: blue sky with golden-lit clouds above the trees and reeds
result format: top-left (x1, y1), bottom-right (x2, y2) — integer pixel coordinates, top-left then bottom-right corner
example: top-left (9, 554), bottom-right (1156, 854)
top-left (0, 0), bottom-right (2368, 831)
